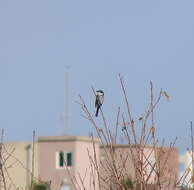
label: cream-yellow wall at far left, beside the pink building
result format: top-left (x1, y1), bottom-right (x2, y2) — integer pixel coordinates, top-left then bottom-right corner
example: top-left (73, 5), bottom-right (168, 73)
top-left (1, 142), bottom-right (38, 190)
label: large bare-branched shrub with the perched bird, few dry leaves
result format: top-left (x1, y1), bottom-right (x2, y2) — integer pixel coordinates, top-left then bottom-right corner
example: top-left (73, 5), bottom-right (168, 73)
top-left (75, 75), bottom-right (193, 190)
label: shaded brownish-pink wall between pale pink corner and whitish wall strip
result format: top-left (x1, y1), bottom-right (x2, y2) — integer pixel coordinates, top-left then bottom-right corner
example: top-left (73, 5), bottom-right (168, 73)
top-left (100, 146), bottom-right (135, 189)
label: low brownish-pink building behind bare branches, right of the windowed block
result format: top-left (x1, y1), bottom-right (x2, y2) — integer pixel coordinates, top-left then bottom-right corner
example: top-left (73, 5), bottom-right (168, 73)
top-left (100, 144), bottom-right (179, 189)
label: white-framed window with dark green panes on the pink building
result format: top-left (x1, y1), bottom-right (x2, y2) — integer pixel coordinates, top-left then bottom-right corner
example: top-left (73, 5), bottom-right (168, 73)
top-left (56, 151), bottom-right (73, 169)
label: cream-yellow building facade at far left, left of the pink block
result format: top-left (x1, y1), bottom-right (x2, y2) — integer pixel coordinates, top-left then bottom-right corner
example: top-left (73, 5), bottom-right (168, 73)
top-left (0, 142), bottom-right (38, 189)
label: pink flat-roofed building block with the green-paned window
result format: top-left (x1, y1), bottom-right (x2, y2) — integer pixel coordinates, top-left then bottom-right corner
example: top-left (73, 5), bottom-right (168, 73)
top-left (37, 136), bottom-right (99, 190)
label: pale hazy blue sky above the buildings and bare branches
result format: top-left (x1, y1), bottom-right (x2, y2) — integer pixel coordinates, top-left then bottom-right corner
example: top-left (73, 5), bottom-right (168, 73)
top-left (0, 0), bottom-right (194, 149)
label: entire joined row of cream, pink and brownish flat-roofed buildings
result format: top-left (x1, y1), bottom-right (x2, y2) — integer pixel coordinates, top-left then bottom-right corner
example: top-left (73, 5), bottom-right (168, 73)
top-left (1, 136), bottom-right (179, 190)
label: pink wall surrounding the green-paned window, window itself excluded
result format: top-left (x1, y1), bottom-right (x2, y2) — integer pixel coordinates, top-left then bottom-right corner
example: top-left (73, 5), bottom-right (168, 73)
top-left (38, 136), bottom-right (99, 190)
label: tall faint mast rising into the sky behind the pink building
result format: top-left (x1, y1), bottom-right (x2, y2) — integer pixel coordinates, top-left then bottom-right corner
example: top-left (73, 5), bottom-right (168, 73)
top-left (64, 65), bottom-right (70, 134)
